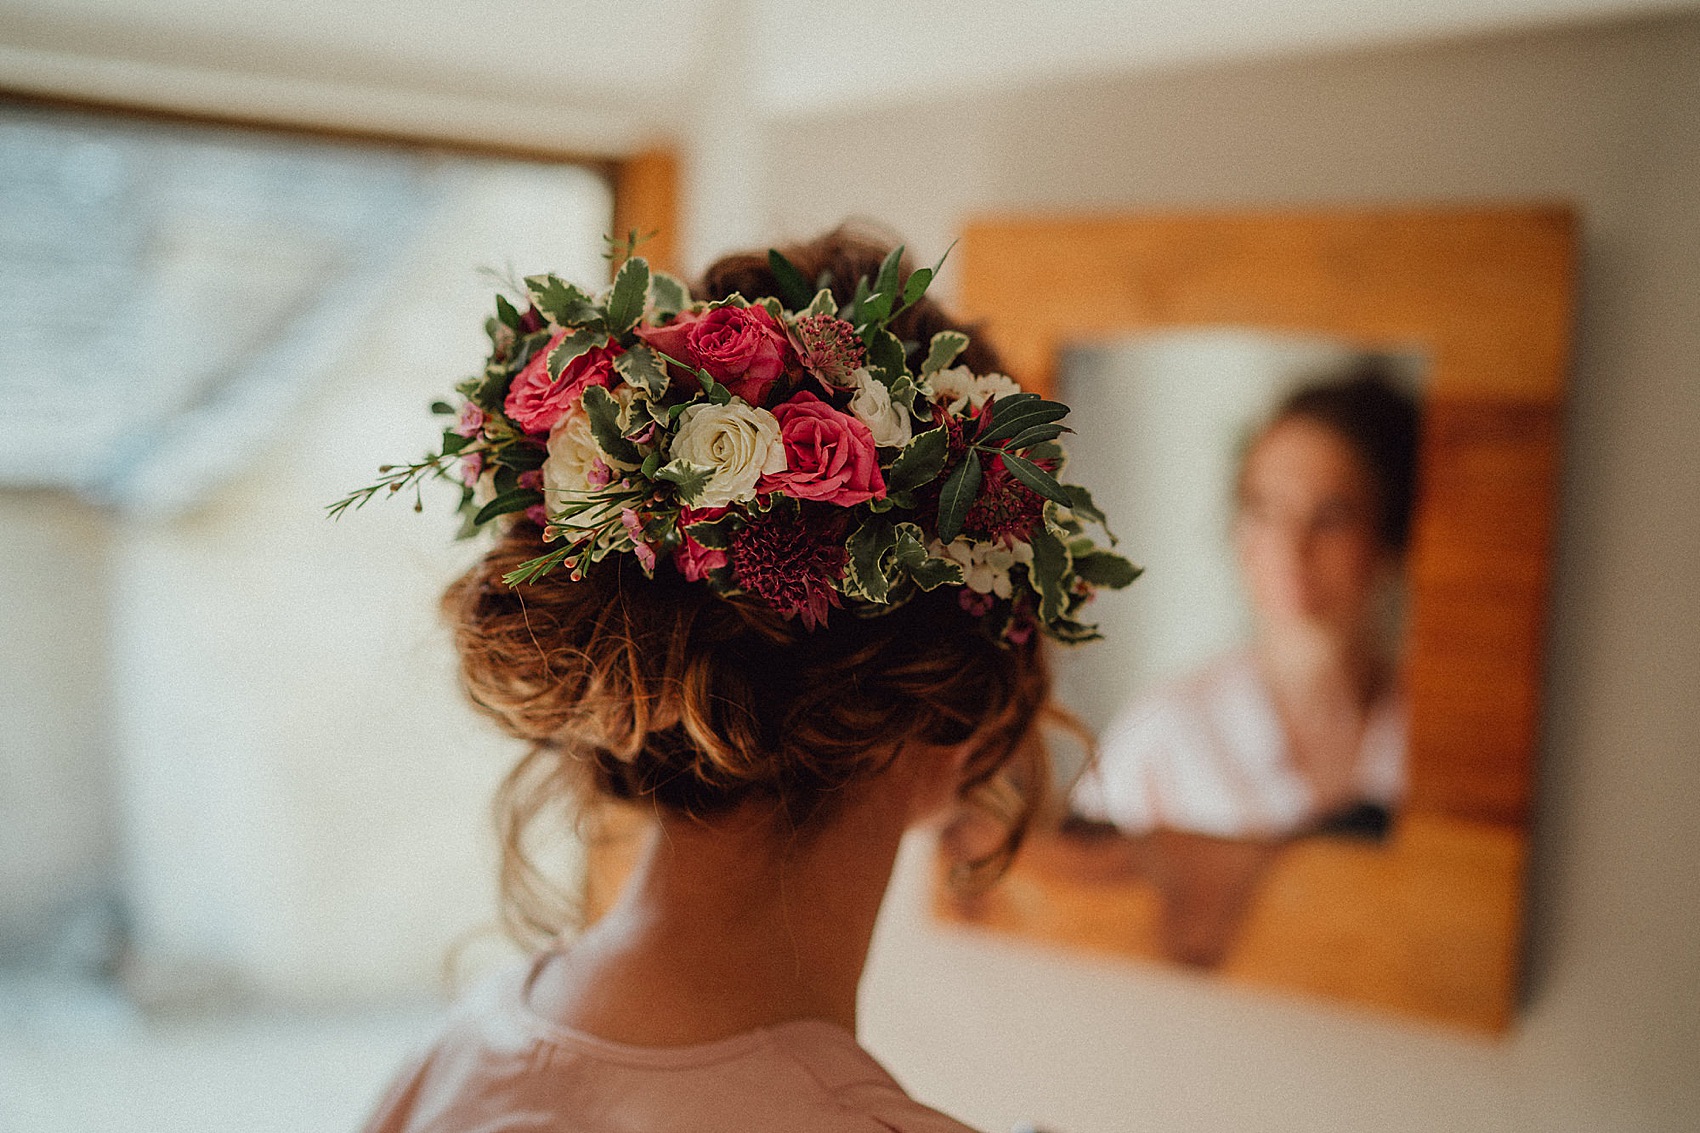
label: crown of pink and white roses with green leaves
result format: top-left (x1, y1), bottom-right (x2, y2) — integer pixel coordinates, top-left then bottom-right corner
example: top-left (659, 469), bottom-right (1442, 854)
top-left (330, 247), bottom-right (1139, 641)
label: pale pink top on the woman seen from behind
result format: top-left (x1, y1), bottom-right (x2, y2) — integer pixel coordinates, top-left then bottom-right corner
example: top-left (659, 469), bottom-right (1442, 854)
top-left (366, 953), bottom-right (974, 1133)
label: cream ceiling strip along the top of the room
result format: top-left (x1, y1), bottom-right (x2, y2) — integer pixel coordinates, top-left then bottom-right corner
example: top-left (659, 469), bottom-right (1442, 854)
top-left (0, 0), bottom-right (1700, 146)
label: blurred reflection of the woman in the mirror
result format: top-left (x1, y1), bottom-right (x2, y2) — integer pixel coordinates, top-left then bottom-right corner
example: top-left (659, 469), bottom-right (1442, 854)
top-left (1073, 366), bottom-right (1418, 965)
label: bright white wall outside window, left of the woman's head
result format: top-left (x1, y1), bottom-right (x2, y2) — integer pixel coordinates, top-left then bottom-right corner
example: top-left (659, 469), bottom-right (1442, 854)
top-left (112, 162), bottom-right (609, 1000)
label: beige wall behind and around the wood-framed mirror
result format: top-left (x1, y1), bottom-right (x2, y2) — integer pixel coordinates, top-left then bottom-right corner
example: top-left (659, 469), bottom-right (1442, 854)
top-left (767, 17), bottom-right (1700, 1133)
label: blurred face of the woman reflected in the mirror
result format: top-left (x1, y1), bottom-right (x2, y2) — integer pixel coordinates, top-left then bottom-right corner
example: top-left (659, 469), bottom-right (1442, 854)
top-left (1234, 417), bottom-right (1394, 635)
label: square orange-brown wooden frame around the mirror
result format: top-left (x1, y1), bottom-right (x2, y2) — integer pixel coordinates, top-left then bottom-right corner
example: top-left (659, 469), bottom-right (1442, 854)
top-left (935, 206), bottom-right (1576, 1031)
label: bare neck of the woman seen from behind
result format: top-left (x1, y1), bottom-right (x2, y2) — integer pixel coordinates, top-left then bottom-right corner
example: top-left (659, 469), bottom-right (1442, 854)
top-left (532, 767), bottom-right (910, 1046)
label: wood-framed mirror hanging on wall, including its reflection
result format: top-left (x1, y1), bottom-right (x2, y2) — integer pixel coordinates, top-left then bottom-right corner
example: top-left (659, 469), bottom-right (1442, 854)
top-left (935, 208), bottom-right (1574, 1029)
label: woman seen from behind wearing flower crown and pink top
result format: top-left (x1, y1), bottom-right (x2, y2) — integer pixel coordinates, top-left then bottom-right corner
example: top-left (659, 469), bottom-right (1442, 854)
top-left (357, 233), bottom-right (1119, 1133)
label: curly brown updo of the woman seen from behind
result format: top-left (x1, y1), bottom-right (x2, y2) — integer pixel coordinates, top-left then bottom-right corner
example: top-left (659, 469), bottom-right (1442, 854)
top-left (444, 222), bottom-right (1049, 944)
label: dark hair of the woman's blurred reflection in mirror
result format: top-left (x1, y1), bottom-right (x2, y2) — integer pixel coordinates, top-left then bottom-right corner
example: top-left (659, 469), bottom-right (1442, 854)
top-left (1239, 357), bottom-right (1421, 555)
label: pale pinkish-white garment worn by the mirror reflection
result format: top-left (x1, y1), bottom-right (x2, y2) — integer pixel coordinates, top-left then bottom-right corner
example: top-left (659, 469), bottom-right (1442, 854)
top-left (1073, 652), bottom-right (1408, 837)
